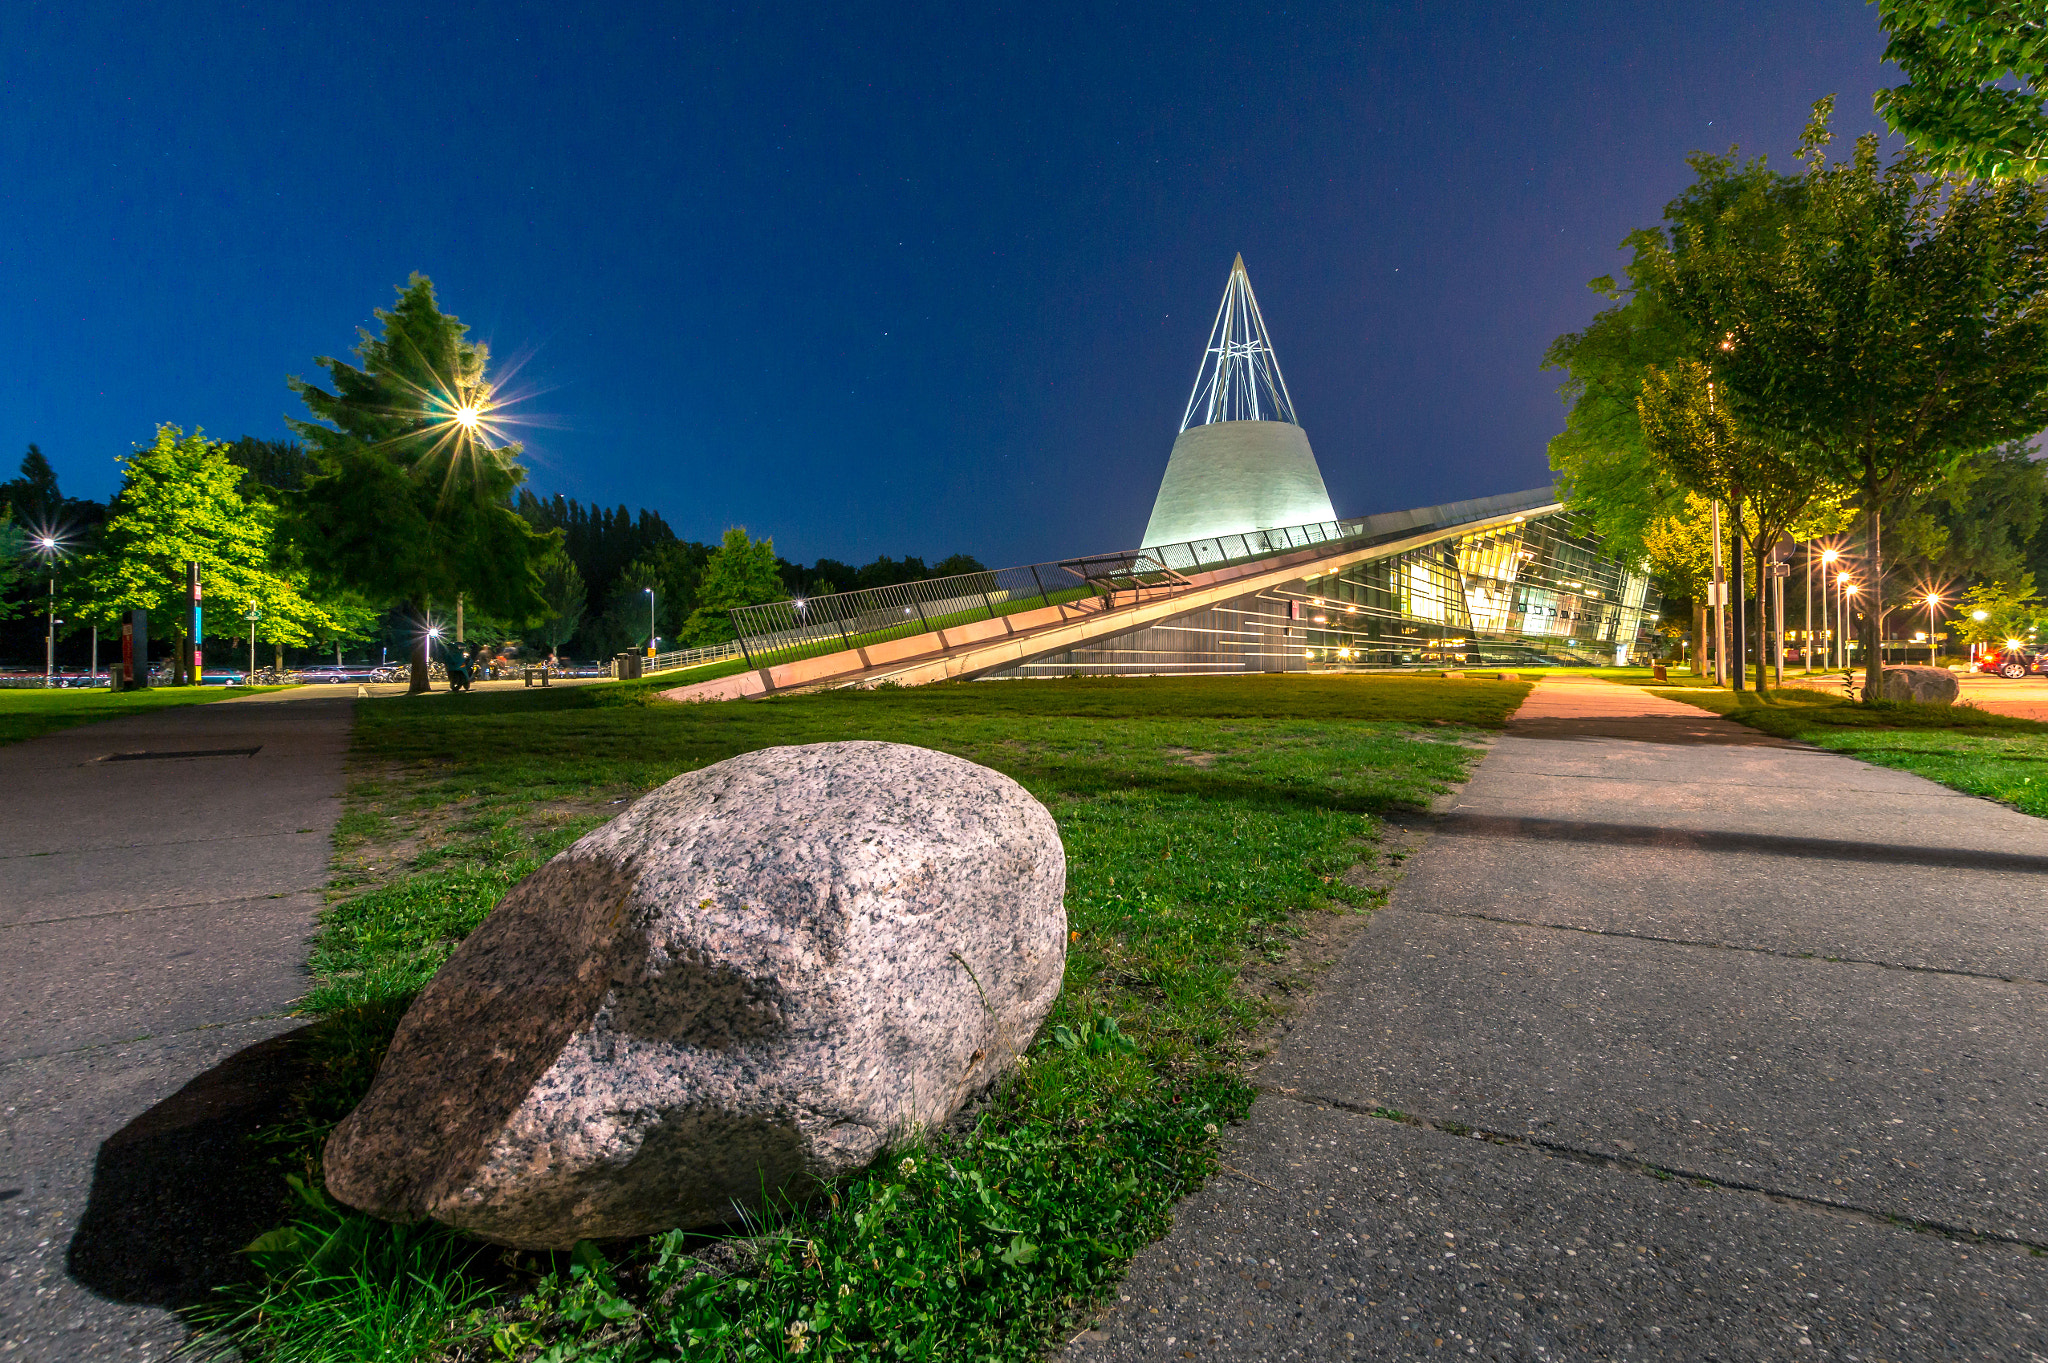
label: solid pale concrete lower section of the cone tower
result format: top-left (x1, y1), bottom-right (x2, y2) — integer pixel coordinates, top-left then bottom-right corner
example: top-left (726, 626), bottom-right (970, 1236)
top-left (1143, 422), bottom-right (1337, 548)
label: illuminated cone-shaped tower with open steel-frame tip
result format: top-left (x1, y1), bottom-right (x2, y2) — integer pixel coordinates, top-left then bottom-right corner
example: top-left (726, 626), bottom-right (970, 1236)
top-left (1145, 256), bottom-right (1337, 548)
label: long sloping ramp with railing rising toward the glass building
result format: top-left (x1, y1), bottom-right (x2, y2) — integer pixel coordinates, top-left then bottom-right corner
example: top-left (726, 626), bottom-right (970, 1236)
top-left (664, 487), bottom-right (1561, 700)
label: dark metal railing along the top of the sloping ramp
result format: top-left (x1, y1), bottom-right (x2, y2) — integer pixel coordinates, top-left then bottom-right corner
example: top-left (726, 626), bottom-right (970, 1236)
top-left (731, 487), bottom-right (1554, 667)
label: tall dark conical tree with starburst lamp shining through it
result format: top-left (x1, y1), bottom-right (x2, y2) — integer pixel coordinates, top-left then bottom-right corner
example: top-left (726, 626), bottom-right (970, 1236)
top-left (285, 274), bottom-right (555, 694)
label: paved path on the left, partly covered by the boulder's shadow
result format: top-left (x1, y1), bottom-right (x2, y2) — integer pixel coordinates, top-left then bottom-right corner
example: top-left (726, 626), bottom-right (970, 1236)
top-left (0, 698), bottom-right (352, 1363)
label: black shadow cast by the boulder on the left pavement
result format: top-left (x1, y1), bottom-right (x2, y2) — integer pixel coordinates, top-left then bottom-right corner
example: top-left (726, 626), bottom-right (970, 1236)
top-left (66, 1027), bottom-right (309, 1308)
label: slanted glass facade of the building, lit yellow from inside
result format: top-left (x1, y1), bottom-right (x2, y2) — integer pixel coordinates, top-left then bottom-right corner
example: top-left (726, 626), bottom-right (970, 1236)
top-left (1004, 512), bottom-right (1659, 677)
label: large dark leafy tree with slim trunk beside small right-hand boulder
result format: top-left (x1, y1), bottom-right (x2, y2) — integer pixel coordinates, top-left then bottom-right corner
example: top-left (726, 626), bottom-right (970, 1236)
top-left (1647, 100), bottom-right (2048, 696)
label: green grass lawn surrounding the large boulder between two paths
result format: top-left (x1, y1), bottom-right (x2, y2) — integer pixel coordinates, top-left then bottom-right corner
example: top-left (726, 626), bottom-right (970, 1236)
top-left (211, 675), bottom-right (1528, 1363)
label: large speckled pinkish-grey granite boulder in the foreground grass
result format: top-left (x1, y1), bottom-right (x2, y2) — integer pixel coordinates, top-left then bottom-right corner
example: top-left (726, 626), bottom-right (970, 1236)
top-left (326, 743), bottom-right (1067, 1248)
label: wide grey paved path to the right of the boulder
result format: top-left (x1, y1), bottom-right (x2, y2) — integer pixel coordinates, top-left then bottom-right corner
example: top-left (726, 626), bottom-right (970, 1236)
top-left (1069, 679), bottom-right (2048, 1363)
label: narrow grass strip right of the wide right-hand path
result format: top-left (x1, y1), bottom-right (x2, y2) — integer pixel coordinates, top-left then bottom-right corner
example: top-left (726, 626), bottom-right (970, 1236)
top-left (1657, 684), bottom-right (2048, 819)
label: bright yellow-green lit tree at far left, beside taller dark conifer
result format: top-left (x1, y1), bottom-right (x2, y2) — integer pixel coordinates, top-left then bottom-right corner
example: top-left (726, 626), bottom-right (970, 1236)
top-left (63, 426), bottom-right (328, 679)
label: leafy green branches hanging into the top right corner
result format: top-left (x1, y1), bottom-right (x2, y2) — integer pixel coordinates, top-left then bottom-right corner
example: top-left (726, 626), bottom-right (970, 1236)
top-left (1876, 0), bottom-right (2048, 180)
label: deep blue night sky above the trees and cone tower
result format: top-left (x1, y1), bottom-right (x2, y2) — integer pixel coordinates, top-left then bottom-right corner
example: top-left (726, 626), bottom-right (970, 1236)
top-left (0, 0), bottom-right (1888, 563)
